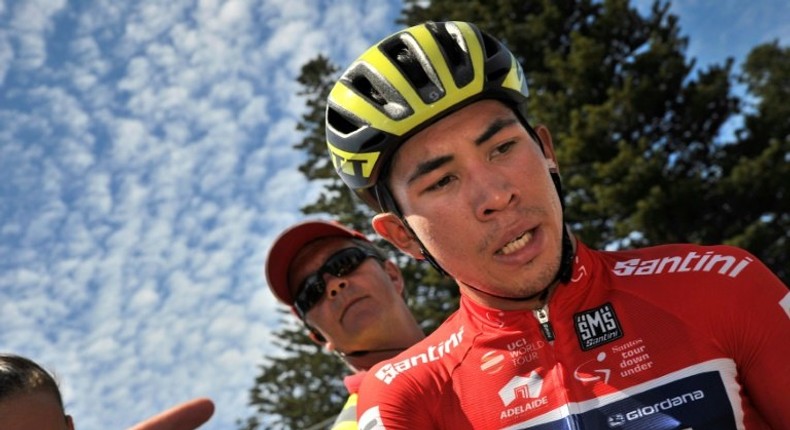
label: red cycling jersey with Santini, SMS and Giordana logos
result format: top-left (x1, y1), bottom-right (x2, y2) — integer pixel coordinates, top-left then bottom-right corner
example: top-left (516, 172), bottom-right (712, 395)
top-left (358, 243), bottom-right (790, 430)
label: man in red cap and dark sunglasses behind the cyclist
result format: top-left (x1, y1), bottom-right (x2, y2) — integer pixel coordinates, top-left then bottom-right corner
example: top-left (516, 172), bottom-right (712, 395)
top-left (266, 220), bottom-right (425, 429)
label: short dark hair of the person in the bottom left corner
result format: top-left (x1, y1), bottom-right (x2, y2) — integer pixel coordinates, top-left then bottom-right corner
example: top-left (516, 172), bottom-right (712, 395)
top-left (0, 354), bottom-right (65, 414)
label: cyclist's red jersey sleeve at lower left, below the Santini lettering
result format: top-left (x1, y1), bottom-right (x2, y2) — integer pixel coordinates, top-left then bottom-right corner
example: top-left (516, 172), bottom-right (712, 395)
top-left (357, 366), bottom-right (435, 430)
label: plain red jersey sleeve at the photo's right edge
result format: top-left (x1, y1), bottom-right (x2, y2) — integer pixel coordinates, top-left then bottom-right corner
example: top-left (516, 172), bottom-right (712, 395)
top-left (728, 247), bottom-right (790, 429)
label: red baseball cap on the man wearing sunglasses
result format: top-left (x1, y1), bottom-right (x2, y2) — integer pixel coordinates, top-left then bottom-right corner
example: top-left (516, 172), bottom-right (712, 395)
top-left (266, 220), bottom-right (370, 307)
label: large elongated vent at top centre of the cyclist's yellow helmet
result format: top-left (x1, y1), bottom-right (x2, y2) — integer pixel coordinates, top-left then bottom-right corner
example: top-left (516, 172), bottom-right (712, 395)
top-left (381, 33), bottom-right (444, 104)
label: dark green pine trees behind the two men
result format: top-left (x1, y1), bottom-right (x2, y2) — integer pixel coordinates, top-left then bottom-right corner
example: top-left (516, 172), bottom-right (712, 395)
top-left (245, 0), bottom-right (790, 429)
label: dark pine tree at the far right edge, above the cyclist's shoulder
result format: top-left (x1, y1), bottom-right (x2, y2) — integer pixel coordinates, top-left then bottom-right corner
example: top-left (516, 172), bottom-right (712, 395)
top-left (716, 42), bottom-right (790, 284)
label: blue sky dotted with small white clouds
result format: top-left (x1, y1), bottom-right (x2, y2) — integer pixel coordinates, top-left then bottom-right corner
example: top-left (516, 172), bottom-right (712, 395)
top-left (0, 0), bottom-right (790, 430)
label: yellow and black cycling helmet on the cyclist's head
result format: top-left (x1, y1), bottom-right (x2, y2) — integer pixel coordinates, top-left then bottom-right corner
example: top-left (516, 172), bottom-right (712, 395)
top-left (326, 21), bottom-right (528, 212)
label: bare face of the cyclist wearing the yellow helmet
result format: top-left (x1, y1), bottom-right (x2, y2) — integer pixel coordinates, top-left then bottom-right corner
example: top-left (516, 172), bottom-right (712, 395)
top-left (382, 100), bottom-right (563, 306)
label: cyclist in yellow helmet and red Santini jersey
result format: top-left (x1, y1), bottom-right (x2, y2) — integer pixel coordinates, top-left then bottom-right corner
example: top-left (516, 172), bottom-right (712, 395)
top-left (326, 22), bottom-right (790, 429)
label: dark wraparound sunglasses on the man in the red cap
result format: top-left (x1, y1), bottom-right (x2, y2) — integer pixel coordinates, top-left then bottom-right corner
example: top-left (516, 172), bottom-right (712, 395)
top-left (294, 248), bottom-right (382, 319)
